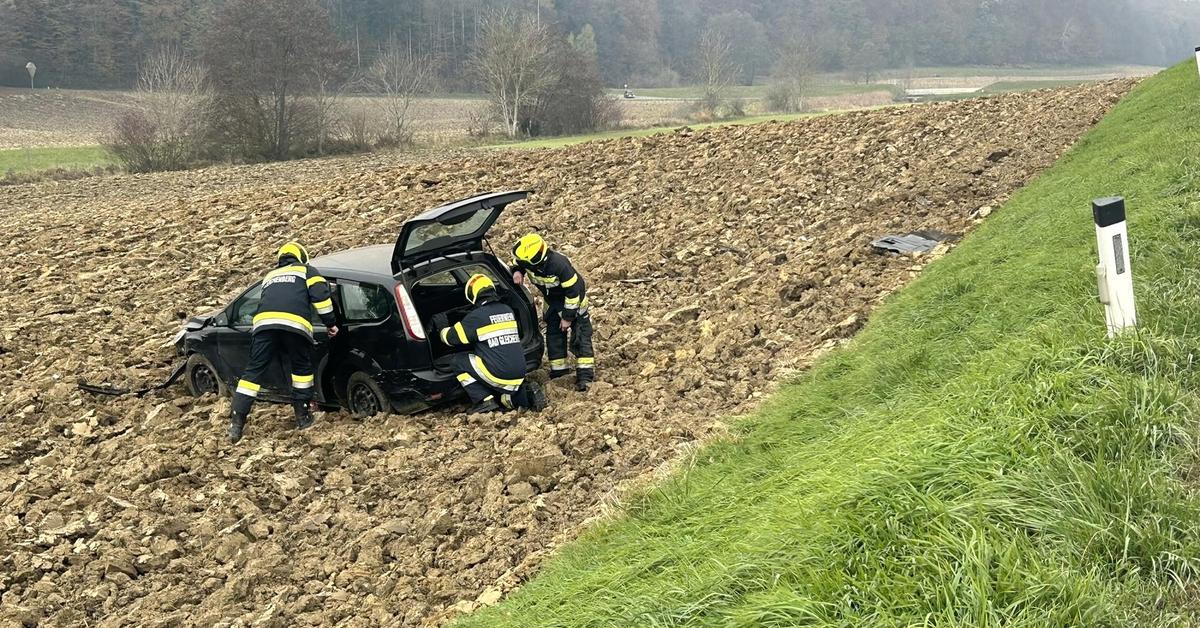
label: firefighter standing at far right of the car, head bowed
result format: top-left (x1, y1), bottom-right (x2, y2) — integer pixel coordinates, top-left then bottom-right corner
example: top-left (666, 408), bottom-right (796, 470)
top-left (512, 233), bottom-right (595, 393)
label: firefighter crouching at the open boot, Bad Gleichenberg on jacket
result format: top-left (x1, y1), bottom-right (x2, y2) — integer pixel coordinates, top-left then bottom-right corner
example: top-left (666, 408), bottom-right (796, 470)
top-left (433, 275), bottom-right (545, 413)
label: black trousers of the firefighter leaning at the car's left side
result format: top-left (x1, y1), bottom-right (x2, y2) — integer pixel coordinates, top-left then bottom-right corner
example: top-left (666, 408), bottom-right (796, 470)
top-left (233, 329), bottom-right (314, 417)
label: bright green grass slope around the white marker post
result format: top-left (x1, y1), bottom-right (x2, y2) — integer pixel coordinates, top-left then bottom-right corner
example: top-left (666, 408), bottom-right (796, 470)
top-left (460, 62), bottom-right (1200, 627)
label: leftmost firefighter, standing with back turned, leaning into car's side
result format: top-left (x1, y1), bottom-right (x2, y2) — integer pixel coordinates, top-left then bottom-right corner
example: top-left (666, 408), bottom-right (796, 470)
top-left (229, 241), bottom-right (337, 443)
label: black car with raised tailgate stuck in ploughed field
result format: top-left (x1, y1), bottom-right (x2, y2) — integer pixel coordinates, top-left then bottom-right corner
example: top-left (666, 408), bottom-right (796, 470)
top-left (175, 191), bottom-right (544, 415)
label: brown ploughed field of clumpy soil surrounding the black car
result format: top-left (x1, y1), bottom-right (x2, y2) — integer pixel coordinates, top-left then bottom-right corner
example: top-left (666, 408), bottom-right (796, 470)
top-left (0, 80), bottom-right (1133, 626)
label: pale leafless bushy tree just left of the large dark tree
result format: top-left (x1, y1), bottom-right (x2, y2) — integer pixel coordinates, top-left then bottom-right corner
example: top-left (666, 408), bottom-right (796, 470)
top-left (107, 47), bottom-right (212, 172)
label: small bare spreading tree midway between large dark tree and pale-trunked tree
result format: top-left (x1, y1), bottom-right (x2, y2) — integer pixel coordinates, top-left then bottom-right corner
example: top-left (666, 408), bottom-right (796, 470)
top-left (366, 37), bottom-right (436, 144)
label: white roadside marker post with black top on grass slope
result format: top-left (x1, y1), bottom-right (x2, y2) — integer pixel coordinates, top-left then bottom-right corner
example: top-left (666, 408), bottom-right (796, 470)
top-left (1092, 196), bottom-right (1138, 337)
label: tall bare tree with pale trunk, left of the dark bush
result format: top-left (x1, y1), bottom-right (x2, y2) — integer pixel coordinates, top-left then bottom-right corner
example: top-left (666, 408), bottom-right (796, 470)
top-left (472, 11), bottom-right (558, 137)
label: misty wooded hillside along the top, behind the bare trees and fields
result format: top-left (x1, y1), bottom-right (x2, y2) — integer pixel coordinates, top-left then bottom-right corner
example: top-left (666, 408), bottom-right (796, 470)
top-left (0, 0), bottom-right (1200, 91)
